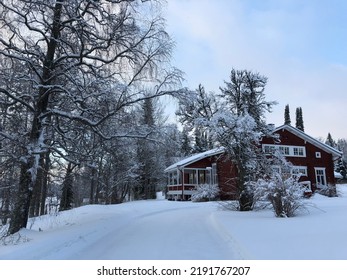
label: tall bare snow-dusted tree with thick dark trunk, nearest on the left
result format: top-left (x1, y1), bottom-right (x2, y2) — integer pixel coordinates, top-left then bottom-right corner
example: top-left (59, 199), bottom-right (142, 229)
top-left (0, 0), bottom-right (181, 234)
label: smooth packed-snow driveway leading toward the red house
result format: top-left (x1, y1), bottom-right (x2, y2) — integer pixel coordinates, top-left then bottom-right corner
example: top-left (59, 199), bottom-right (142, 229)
top-left (77, 203), bottom-right (237, 260)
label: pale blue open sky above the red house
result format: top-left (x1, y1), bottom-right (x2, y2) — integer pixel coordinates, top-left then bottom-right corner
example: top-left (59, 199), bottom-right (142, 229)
top-left (163, 0), bottom-right (347, 140)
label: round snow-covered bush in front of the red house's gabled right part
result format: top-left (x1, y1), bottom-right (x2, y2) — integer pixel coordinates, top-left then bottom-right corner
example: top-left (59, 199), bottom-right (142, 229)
top-left (254, 173), bottom-right (304, 217)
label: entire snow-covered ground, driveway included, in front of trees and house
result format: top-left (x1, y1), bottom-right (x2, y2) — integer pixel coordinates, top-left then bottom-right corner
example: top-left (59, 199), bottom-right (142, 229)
top-left (0, 185), bottom-right (347, 260)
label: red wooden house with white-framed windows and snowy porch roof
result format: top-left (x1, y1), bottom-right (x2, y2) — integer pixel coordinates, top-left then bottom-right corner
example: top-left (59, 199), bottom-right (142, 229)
top-left (165, 125), bottom-right (342, 200)
